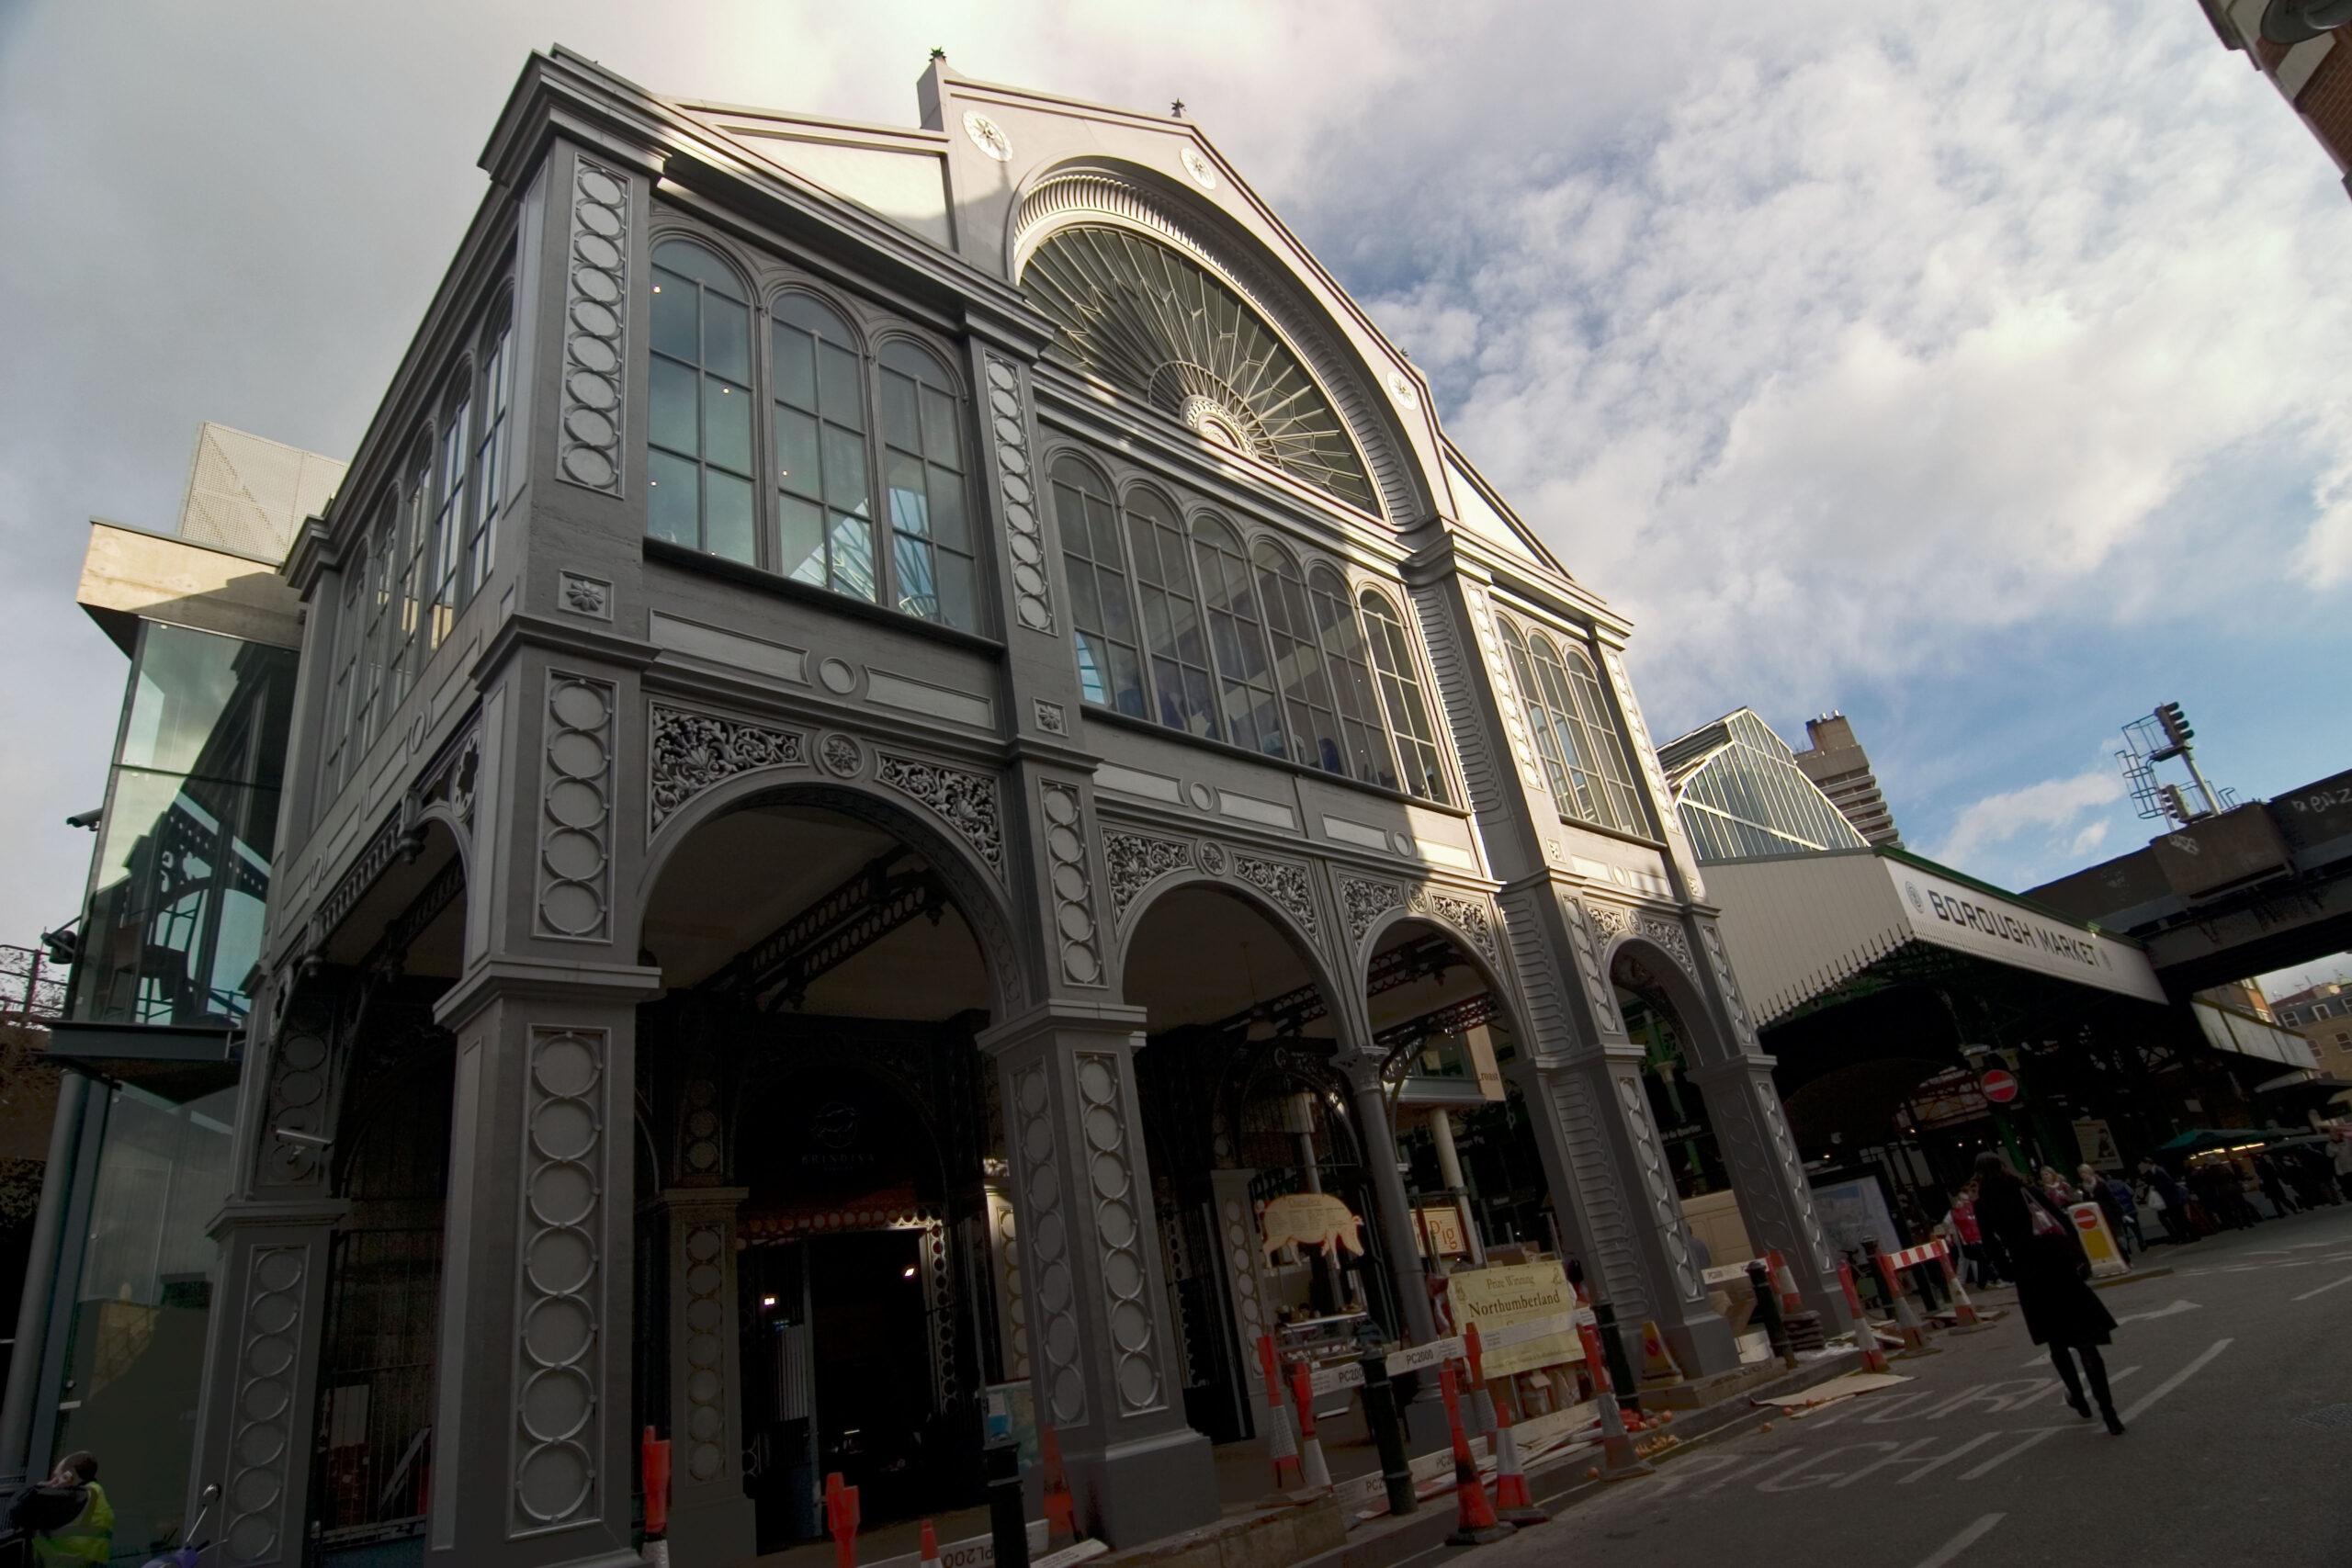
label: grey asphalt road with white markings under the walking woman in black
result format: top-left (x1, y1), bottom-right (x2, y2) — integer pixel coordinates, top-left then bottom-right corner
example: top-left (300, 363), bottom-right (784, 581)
top-left (1448, 1203), bottom-right (2352, 1568)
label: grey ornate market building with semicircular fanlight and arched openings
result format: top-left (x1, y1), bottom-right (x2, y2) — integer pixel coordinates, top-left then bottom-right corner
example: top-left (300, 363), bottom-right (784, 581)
top-left (101, 50), bottom-right (1847, 1568)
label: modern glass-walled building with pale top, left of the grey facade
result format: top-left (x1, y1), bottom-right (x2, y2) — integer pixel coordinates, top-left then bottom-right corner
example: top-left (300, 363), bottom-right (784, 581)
top-left (0, 425), bottom-right (341, 1561)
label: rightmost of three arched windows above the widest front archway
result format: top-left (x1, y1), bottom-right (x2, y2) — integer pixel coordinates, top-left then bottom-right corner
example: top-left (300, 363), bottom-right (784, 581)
top-left (882, 339), bottom-right (978, 632)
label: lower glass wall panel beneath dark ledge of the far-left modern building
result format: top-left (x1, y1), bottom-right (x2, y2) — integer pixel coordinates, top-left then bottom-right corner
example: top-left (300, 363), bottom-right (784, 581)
top-left (50, 1086), bottom-right (238, 1561)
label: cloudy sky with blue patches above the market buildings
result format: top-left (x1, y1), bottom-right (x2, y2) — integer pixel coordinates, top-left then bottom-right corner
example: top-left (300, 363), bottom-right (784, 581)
top-left (0, 0), bottom-right (2352, 991)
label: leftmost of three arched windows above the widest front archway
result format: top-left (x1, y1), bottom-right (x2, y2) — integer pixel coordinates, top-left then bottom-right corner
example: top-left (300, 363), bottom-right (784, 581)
top-left (644, 240), bottom-right (757, 562)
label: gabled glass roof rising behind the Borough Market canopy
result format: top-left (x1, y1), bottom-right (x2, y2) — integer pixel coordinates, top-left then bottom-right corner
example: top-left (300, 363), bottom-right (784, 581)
top-left (1658, 707), bottom-right (1865, 863)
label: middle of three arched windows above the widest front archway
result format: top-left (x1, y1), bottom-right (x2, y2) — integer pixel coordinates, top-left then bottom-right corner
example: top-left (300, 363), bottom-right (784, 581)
top-left (769, 294), bottom-right (877, 600)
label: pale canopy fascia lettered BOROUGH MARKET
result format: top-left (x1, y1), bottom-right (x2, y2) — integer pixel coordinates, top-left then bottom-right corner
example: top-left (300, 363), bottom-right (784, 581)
top-left (1705, 844), bottom-right (2166, 1025)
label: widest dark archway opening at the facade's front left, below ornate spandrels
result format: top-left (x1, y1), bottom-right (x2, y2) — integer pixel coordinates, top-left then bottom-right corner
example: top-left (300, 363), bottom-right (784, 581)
top-left (638, 785), bottom-right (1013, 1563)
